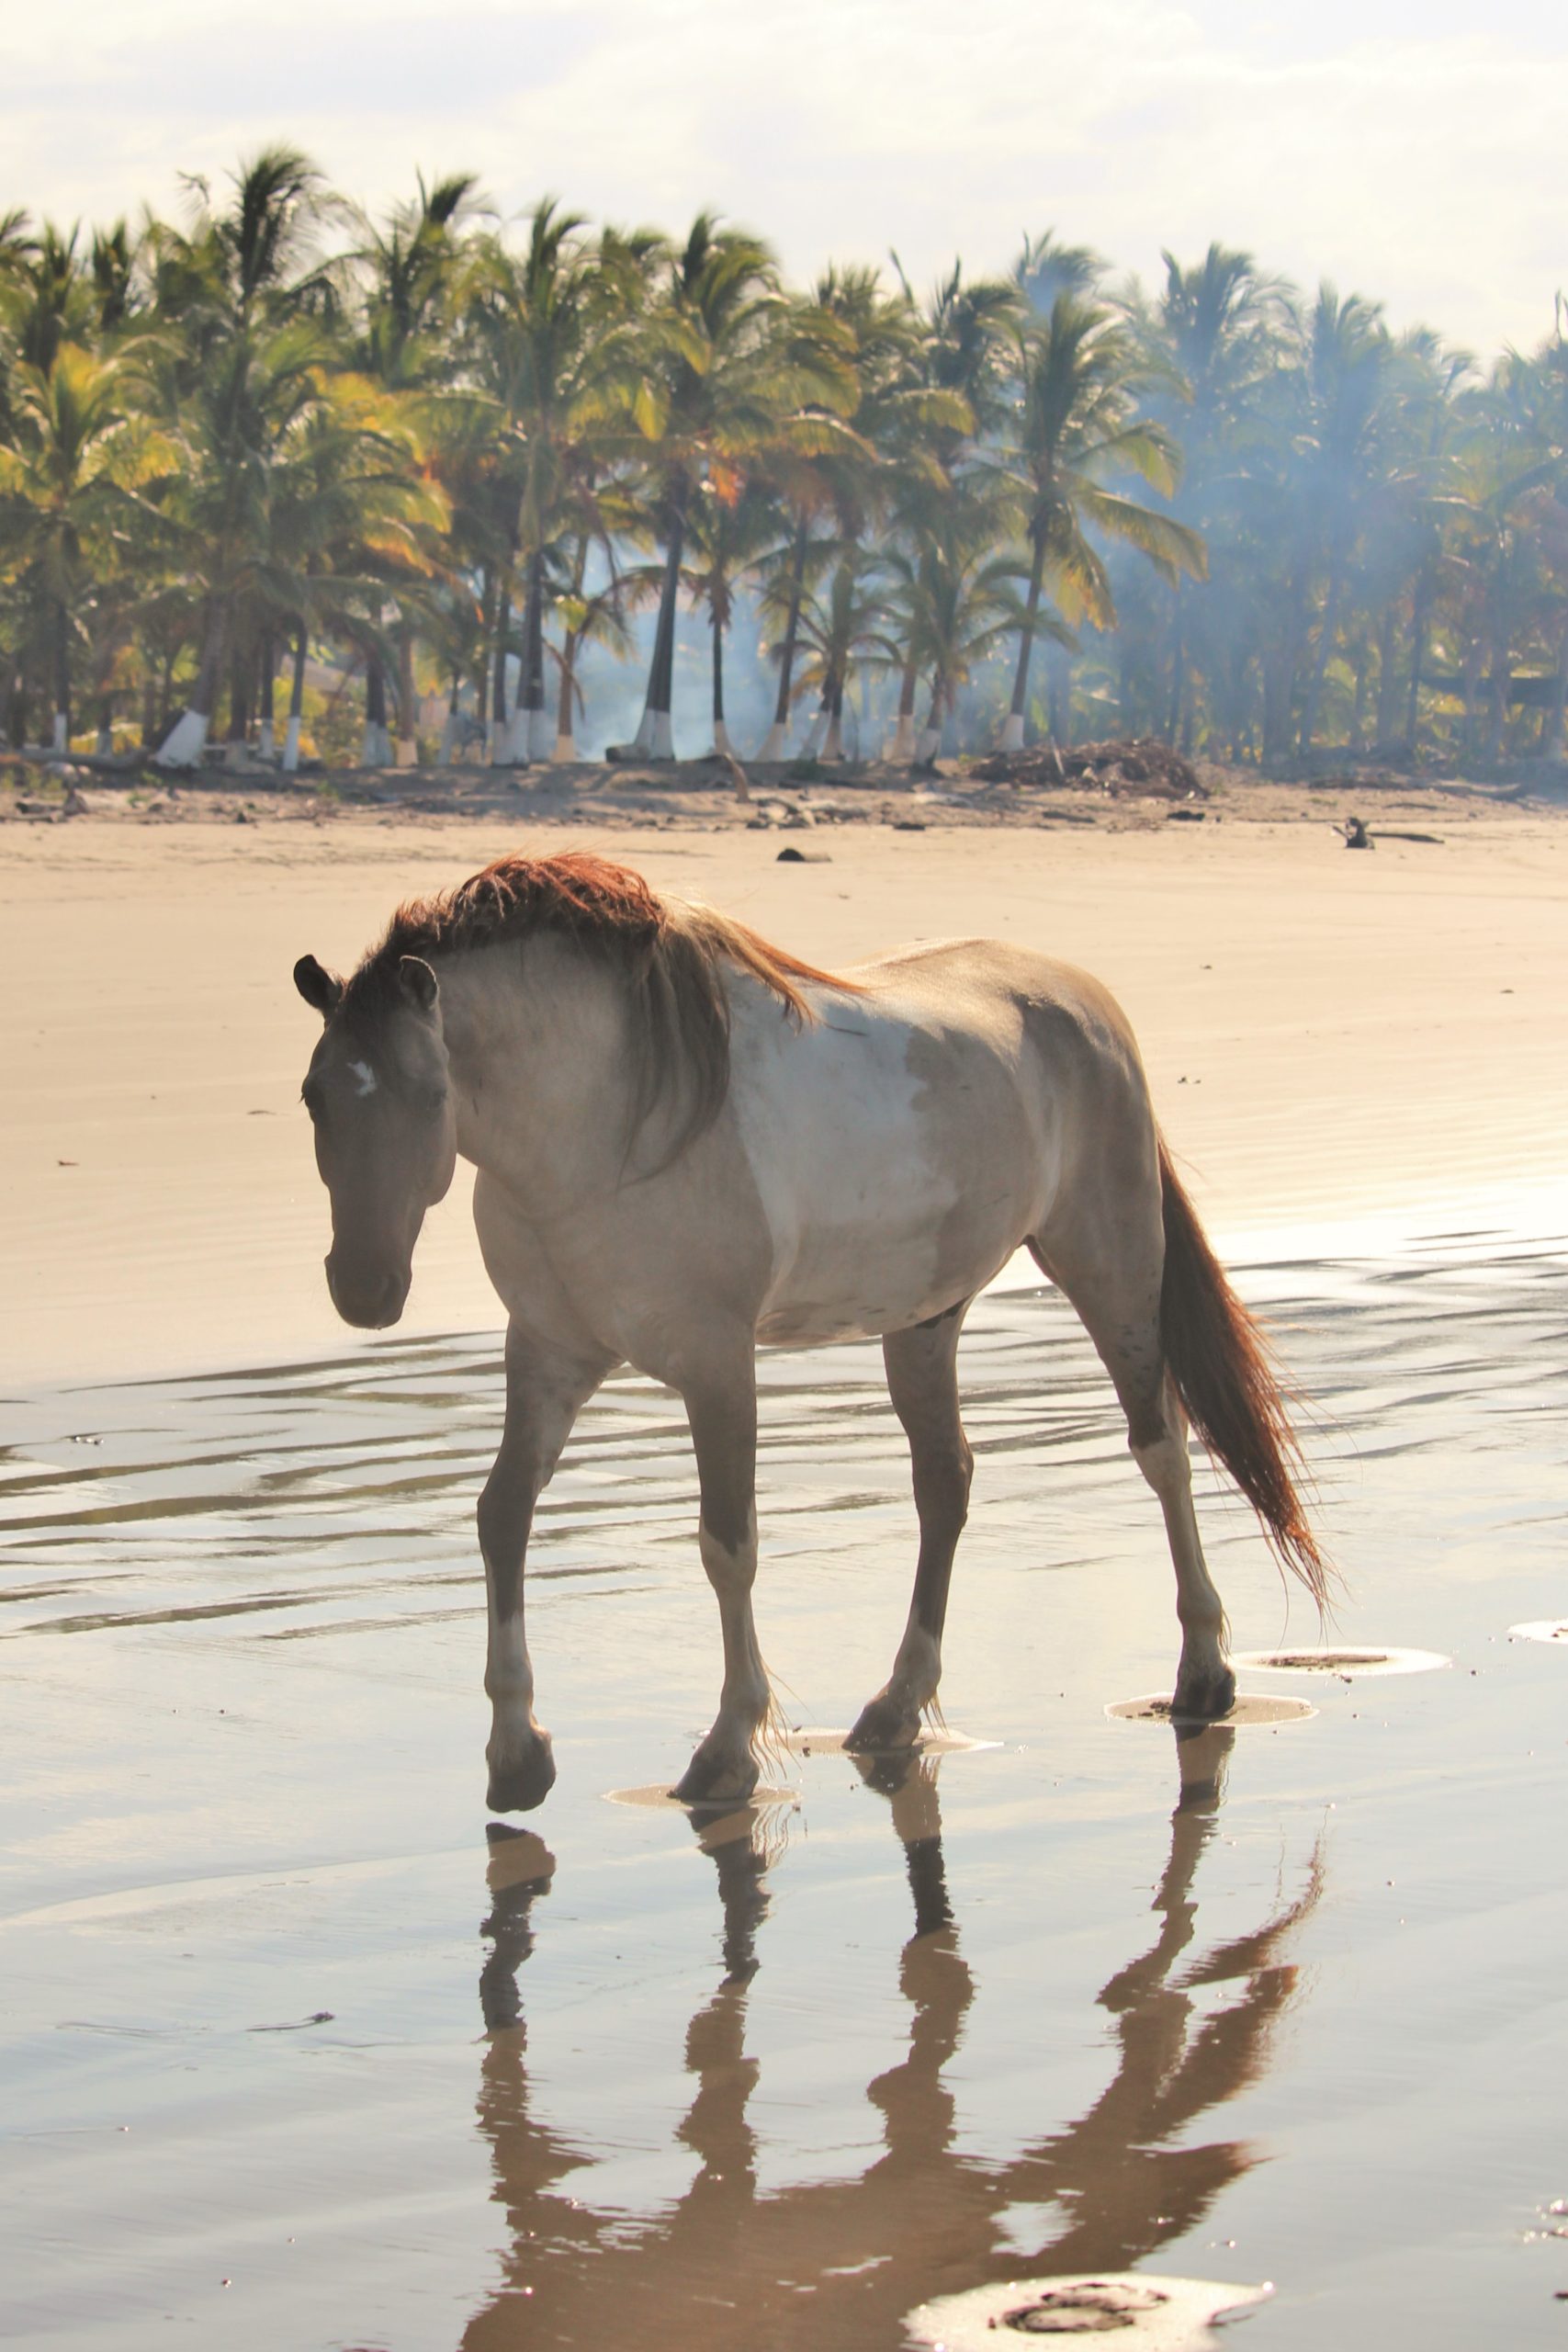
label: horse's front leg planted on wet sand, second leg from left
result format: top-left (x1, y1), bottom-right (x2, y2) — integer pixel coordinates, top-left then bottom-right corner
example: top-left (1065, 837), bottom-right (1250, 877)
top-left (674, 1339), bottom-right (769, 1804)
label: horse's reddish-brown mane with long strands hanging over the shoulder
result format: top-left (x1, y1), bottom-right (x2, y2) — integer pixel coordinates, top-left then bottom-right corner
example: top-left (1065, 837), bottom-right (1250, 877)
top-left (344, 849), bottom-right (856, 1164)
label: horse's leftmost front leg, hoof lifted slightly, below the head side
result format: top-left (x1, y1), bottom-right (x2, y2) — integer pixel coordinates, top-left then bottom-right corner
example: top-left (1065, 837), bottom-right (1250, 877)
top-left (479, 1324), bottom-right (611, 1814)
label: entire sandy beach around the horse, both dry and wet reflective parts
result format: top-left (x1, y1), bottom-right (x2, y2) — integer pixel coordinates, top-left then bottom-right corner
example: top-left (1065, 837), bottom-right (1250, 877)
top-left (0, 799), bottom-right (1568, 2352)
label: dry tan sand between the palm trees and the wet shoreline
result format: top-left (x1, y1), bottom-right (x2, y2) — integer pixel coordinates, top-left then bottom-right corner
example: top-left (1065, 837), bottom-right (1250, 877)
top-left (0, 793), bottom-right (1568, 1387)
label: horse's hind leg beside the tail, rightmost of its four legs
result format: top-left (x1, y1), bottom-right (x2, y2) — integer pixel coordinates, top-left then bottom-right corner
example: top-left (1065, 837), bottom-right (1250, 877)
top-left (1030, 1204), bottom-right (1236, 1722)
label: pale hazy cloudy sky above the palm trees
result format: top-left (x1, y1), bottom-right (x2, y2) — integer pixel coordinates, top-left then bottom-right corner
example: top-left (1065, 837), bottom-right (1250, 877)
top-left (0, 0), bottom-right (1568, 350)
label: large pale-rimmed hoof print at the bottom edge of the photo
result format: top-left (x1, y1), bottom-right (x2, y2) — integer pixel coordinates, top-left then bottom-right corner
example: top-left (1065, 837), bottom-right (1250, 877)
top-left (905, 2269), bottom-right (1274, 2352)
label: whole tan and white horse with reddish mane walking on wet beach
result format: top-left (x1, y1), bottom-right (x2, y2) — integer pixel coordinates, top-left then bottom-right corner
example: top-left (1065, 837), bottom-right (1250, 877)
top-left (294, 852), bottom-right (1325, 1814)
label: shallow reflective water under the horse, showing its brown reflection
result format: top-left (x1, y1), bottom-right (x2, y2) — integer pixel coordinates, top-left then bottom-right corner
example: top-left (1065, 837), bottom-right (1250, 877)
top-left (0, 1235), bottom-right (1568, 2352)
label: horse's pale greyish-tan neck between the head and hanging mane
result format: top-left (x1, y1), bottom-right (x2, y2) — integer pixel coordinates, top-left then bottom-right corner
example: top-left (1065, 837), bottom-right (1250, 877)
top-left (440, 938), bottom-right (627, 1209)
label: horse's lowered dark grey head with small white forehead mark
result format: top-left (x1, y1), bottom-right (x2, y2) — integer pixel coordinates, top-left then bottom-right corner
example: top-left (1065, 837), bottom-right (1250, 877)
top-left (294, 955), bottom-right (456, 1331)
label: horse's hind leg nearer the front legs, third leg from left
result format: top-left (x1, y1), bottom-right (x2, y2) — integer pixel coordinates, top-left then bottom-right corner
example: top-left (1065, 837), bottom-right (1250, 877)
top-left (849, 1298), bottom-right (976, 1747)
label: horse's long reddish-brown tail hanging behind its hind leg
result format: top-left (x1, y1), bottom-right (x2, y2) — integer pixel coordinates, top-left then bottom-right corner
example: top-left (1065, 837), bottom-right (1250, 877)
top-left (1159, 1141), bottom-right (1328, 1609)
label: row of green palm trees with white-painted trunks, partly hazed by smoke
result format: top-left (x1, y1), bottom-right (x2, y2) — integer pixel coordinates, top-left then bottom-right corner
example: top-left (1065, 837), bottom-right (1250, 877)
top-left (0, 148), bottom-right (1568, 767)
